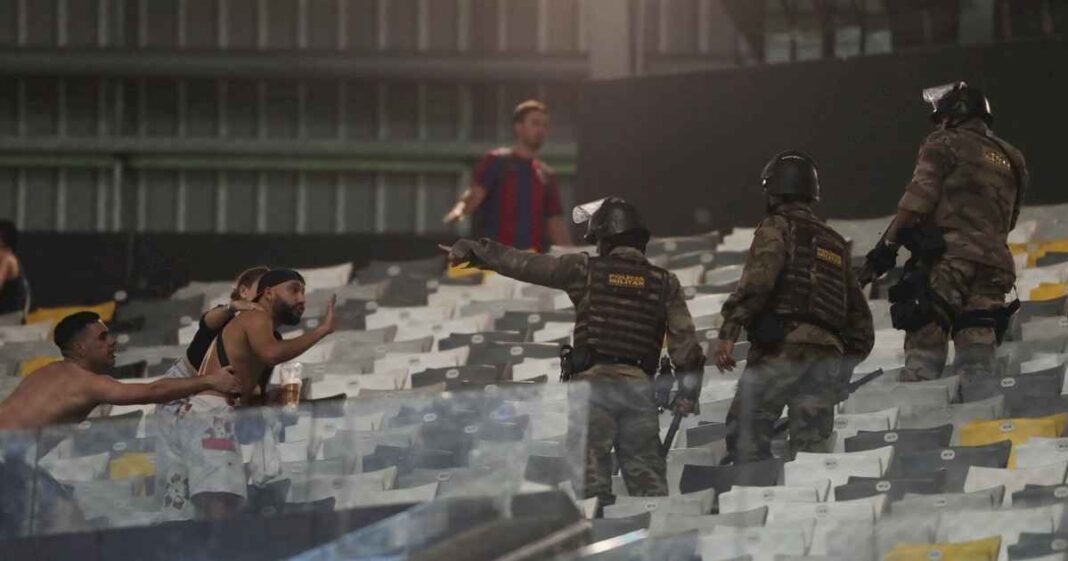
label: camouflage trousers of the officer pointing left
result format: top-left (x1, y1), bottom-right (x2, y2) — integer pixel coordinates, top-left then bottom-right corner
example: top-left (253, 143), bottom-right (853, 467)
top-left (568, 364), bottom-right (668, 505)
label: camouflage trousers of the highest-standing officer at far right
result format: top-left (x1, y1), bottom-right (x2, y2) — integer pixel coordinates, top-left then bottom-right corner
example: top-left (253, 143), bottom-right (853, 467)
top-left (900, 259), bottom-right (1016, 381)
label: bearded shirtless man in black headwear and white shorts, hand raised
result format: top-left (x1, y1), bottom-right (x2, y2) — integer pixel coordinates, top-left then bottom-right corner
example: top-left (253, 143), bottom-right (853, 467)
top-left (157, 269), bottom-right (334, 519)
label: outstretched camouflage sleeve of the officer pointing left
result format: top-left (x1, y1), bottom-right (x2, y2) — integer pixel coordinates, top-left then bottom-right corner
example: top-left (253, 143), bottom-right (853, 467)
top-left (474, 239), bottom-right (588, 291)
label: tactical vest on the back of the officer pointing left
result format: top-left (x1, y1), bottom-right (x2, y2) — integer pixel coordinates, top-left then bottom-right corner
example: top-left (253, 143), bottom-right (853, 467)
top-left (575, 255), bottom-right (670, 375)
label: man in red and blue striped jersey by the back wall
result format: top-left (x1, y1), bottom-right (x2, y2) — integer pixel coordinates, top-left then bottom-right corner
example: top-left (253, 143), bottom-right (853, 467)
top-left (444, 100), bottom-right (571, 251)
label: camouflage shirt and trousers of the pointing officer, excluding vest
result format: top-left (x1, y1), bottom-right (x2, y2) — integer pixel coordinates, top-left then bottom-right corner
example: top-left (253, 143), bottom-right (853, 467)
top-left (463, 239), bottom-right (705, 505)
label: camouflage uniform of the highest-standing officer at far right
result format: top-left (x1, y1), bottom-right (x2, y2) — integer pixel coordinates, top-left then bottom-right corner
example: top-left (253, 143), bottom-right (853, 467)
top-left (898, 119), bottom-right (1028, 380)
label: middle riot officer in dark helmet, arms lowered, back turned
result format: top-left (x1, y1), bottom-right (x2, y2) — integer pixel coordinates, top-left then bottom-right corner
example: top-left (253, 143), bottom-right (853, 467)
top-left (713, 152), bottom-right (875, 463)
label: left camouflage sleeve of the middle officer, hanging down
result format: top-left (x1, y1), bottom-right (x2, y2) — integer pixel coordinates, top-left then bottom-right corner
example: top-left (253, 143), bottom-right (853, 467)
top-left (720, 217), bottom-right (786, 341)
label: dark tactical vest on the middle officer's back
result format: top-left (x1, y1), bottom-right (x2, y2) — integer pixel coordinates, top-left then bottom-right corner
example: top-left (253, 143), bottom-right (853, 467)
top-left (770, 215), bottom-right (850, 338)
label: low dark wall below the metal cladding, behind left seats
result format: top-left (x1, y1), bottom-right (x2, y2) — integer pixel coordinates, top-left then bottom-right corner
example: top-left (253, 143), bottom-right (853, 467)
top-left (18, 232), bottom-right (447, 307)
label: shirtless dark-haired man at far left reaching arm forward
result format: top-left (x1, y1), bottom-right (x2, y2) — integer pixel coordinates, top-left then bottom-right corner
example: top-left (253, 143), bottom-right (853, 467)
top-left (0, 312), bottom-right (241, 431)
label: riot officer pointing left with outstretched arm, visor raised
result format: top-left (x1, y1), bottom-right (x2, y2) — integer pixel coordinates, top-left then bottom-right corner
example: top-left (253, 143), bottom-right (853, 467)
top-left (440, 197), bottom-right (705, 507)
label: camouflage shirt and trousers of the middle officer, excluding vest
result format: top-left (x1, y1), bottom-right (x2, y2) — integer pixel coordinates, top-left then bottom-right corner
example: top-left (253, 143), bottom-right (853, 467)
top-left (720, 202), bottom-right (875, 463)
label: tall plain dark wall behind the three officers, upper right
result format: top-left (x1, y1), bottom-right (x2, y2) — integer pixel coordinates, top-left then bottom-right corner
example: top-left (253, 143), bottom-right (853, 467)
top-left (576, 43), bottom-right (1068, 235)
